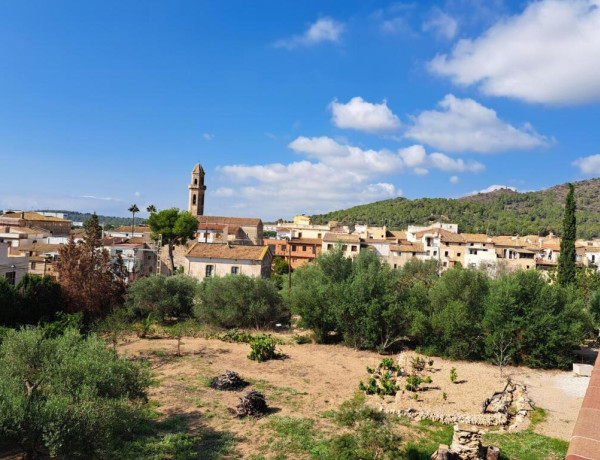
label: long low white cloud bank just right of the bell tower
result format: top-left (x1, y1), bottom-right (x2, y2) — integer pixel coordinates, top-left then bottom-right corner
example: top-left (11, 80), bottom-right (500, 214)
top-left (215, 136), bottom-right (484, 218)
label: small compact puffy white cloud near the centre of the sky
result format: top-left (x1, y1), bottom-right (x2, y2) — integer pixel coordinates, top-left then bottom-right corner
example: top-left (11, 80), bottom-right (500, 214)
top-left (330, 97), bottom-right (401, 132)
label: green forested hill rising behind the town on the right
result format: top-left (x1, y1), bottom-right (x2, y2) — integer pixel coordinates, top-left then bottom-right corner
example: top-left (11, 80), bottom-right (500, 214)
top-left (312, 178), bottom-right (600, 238)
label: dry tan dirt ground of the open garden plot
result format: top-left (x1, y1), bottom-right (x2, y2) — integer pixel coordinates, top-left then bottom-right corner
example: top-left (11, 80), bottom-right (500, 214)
top-left (119, 336), bottom-right (586, 458)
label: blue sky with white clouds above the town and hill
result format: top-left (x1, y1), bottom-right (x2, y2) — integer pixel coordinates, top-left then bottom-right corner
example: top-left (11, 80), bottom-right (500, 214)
top-left (0, 0), bottom-right (600, 219)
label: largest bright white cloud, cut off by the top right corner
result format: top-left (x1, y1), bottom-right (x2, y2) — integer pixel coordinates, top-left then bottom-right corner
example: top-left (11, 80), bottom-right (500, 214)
top-left (429, 0), bottom-right (600, 104)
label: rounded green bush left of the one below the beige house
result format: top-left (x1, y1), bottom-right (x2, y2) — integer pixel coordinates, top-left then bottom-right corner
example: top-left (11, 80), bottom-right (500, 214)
top-left (125, 275), bottom-right (198, 321)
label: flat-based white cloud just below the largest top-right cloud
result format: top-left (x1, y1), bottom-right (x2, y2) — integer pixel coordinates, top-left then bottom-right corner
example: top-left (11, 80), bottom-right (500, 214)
top-left (405, 94), bottom-right (549, 153)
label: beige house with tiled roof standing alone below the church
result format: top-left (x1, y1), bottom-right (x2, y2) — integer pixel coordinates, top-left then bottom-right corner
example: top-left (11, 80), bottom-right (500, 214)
top-left (185, 243), bottom-right (273, 281)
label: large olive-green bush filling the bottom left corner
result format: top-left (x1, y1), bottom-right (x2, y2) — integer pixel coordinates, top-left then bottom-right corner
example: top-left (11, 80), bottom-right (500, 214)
top-left (0, 328), bottom-right (149, 458)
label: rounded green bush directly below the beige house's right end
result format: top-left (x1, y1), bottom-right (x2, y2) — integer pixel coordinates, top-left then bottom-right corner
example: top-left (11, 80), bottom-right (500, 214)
top-left (194, 275), bottom-right (287, 329)
